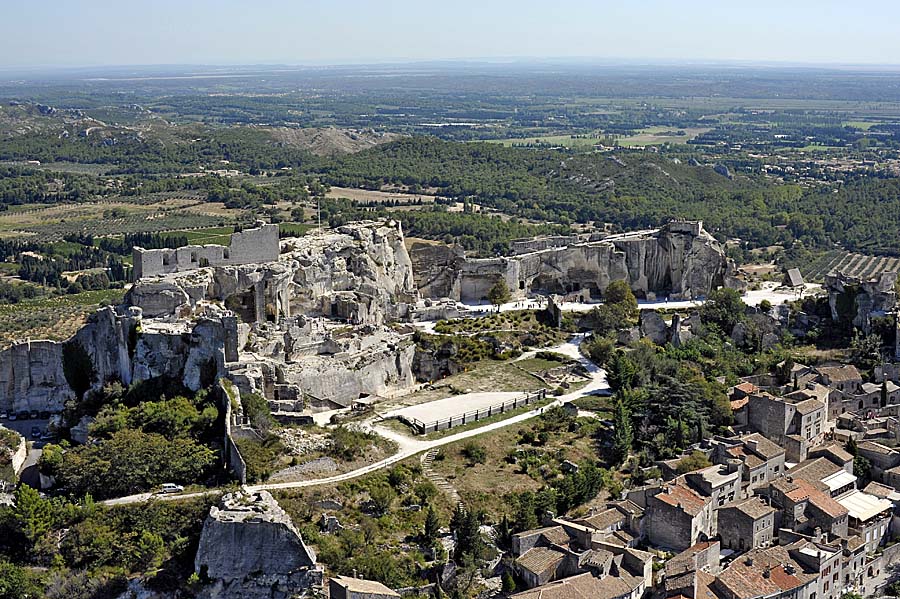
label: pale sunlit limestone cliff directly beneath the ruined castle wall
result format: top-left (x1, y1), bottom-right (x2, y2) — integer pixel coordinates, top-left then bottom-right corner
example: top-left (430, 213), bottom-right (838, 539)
top-left (126, 221), bottom-right (418, 325)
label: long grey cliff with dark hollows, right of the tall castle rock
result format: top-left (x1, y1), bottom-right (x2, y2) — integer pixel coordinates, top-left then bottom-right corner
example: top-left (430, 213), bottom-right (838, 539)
top-left (415, 222), bottom-right (739, 301)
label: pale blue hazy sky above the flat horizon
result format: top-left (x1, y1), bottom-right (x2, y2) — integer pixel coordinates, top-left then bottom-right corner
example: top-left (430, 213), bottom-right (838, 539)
top-left (0, 0), bottom-right (900, 67)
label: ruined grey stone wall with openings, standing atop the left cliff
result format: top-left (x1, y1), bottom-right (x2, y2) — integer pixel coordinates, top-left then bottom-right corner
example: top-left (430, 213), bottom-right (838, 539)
top-left (132, 224), bottom-right (279, 281)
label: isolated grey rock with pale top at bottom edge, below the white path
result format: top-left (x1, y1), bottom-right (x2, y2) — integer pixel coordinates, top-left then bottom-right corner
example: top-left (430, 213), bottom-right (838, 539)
top-left (194, 491), bottom-right (323, 599)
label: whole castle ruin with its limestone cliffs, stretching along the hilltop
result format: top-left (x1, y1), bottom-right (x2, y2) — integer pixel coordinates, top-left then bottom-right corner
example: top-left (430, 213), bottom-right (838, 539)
top-left (0, 221), bottom-right (731, 414)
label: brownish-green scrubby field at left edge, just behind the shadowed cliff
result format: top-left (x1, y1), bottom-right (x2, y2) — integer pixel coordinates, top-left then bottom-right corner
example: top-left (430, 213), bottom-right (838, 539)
top-left (0, 289), bottom-right (125, 346)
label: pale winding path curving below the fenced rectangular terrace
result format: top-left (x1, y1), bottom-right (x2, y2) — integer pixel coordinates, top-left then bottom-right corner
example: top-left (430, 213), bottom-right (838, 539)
top-left (102, 334), bottom-right (609, 505)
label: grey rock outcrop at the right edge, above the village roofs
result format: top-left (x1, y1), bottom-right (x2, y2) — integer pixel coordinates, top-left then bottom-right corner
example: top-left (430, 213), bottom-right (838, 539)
top-left (825, 272), bottom-right (897, 333)
